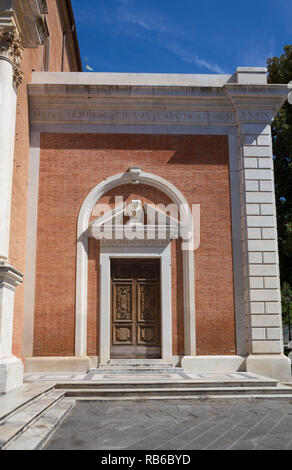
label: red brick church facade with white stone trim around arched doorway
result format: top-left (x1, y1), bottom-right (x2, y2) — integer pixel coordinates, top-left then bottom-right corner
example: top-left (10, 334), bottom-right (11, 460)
top-left (0, 1), bottom-right (291, 391)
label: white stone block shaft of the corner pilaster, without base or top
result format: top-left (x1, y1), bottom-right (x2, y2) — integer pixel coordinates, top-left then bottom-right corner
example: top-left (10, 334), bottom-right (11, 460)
top-left (240, 124), bottom-right (282, 354)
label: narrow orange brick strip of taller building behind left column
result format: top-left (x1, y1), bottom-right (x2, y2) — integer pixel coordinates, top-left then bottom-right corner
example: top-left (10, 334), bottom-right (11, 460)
top-left (9, 0), bottom-right (80, 357)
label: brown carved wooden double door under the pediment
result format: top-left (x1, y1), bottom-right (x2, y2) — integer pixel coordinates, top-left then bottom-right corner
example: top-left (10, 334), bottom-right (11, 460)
top-left (111, 259), bottom-right (161, 359)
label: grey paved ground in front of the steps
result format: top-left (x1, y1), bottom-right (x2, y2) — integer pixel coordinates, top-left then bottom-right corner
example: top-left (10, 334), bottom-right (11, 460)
top-left (46, 400), bottom-right (292, 450)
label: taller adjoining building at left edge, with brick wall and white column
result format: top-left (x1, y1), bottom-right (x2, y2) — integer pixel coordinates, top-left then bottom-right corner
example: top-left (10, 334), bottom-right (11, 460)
top-left (0, 0), bottom-right (82, 392)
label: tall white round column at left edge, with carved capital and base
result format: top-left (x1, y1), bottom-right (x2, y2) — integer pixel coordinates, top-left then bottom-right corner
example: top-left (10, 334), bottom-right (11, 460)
top-left (0, 27), bottom-right (23, 393)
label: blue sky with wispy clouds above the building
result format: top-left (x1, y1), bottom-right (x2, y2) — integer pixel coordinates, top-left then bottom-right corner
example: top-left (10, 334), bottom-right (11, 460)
top-left (72, 0), bottom-right (292, 73)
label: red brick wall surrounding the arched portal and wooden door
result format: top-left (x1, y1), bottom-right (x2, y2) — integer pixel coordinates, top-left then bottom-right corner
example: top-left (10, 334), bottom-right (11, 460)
top-left (34, 134), bottom-right (235, 356)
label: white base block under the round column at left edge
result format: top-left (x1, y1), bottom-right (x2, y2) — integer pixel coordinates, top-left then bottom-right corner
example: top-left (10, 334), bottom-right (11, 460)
top-left (0, 356), bottom-right (23, 393)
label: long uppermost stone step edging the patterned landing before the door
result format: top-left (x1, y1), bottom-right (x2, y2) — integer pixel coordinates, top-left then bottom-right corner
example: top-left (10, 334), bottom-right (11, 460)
top-left (56, 376), bottom-right (278, 391)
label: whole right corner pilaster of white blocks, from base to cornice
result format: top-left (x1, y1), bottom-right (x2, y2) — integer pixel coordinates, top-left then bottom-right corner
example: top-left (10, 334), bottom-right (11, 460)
top-left (228, 71), bottom-right (291, 381)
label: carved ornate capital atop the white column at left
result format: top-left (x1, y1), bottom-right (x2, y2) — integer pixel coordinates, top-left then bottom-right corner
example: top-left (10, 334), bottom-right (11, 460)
top-left (0, 28), bottom-right (23, 88)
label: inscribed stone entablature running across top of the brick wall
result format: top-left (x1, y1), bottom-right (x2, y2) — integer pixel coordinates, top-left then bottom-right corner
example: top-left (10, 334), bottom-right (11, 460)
top-left (29, 69), bottom-right (288, 132)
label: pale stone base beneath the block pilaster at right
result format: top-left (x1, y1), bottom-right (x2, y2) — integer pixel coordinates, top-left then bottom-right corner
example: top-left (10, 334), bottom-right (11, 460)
top-left (246, 355), bottom-right (292, 382)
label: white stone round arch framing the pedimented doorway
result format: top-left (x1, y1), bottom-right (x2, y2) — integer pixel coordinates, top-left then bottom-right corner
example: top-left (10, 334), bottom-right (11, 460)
top-left (75, 168), bottom-right (196, 357)
